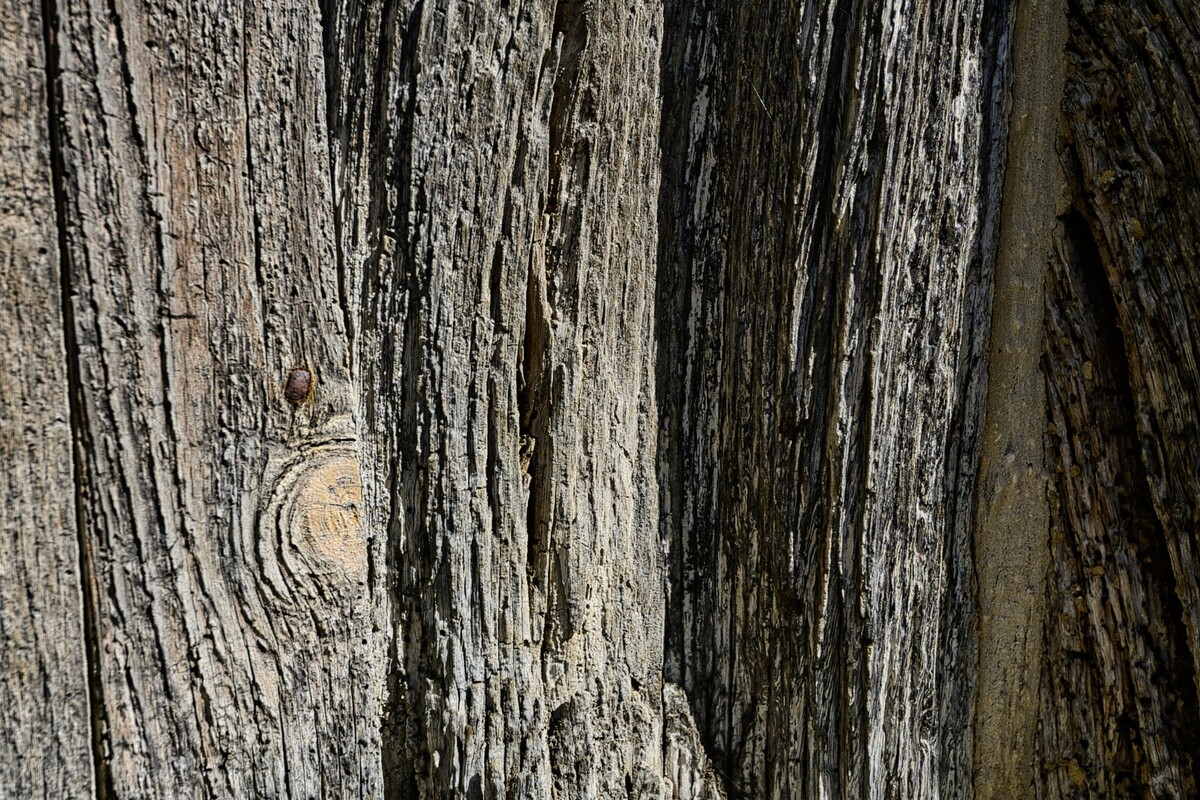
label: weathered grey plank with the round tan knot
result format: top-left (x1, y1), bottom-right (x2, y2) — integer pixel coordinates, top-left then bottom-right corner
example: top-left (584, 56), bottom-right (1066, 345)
top-left (48, 0), bottom-right (383, 798)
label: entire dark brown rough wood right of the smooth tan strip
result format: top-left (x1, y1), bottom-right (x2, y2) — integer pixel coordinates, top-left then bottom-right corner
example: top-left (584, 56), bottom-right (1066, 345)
top-left (1038, 1), bottom-right (1200, 798)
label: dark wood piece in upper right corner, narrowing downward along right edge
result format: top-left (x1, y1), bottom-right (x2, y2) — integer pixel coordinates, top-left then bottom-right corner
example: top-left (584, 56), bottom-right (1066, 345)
top-left (1063, 2), bottom-right (1200, 695)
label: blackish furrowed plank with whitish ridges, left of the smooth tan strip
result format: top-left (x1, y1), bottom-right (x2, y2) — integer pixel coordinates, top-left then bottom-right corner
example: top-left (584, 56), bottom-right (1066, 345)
top-left (659, 1), bottom-right (1008, 798)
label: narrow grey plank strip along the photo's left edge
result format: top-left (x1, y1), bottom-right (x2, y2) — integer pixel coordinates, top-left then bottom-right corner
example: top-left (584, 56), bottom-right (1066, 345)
top-left (0, 0), bottom-right (94, 800)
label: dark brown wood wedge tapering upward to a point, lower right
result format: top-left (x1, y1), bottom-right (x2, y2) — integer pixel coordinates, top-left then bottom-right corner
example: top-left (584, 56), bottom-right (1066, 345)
top-left (1038, 215), bottom-right (1200, 798)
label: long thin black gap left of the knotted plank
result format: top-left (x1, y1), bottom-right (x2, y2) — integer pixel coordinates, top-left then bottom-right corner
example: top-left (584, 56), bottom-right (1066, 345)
top-left (41, 0), bottom-right (116, 800)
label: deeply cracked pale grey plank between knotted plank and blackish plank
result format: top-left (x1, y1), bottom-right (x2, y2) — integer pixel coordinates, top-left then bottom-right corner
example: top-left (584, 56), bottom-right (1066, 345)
top-left (329, 0), bottom-right (664, 798)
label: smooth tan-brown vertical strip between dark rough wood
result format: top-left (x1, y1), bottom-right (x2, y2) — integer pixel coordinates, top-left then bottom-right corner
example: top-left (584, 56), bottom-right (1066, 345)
top-left (974, 0), bottom-right (1067, 800)
